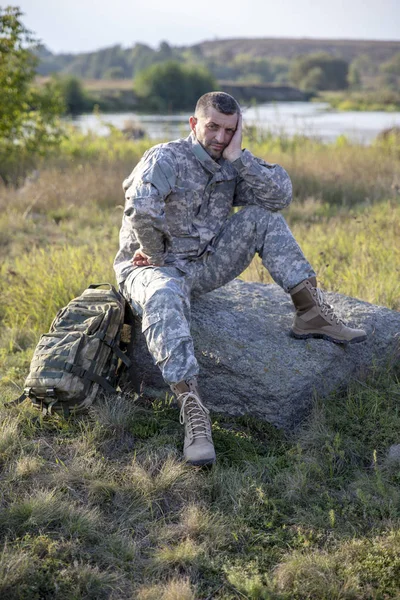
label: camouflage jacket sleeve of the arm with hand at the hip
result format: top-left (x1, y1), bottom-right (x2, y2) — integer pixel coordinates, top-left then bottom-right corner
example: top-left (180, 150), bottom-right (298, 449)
top-left (123, 147), bottom-right (177, 265)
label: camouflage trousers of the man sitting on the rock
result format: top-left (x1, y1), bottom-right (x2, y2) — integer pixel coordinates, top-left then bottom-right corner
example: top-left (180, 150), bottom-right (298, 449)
top-left (123, 206), bottom-right (315, 384)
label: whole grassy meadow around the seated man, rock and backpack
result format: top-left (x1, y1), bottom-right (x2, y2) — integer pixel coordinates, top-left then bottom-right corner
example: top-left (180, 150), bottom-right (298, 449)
top-left (0, 132), bottom-right (400, 600)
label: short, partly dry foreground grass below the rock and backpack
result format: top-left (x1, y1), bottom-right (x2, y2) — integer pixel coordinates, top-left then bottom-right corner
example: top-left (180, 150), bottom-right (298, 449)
top-left (0, 373), bottom-right (400, 598)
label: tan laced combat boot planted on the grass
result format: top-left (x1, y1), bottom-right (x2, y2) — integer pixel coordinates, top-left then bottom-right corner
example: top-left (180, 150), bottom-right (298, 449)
top-left (171, 379), bottom-right (216, 466)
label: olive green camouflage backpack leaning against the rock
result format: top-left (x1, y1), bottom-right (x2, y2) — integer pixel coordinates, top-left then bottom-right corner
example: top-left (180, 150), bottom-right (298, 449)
top-left (16, 283), bottom-right (131, 416)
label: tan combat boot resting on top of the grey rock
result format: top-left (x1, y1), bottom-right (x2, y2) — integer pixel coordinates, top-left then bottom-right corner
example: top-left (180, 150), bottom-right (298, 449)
top-left (290, 277), bottom-right (367, 344)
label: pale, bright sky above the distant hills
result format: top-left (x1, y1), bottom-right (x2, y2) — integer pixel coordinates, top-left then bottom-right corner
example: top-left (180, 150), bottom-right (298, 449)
top-left (13, 0), bottom-right (400, 53)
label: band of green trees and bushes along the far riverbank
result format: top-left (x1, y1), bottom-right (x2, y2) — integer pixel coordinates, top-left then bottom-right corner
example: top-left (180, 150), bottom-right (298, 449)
top-left (34, 43), bottom-right (400, 115)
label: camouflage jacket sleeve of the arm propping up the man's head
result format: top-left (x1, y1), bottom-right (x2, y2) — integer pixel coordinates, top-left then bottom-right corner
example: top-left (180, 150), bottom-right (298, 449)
top-left (232, 150), bottom-right (292, 211)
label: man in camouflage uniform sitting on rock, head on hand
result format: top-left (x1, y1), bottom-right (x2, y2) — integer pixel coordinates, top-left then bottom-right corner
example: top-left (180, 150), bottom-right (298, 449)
top-left (114, 92), bottom-right (366, 465)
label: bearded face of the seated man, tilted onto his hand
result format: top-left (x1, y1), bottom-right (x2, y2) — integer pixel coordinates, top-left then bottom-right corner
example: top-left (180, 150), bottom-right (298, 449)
top-left (189, 107), bottom-right (238, 160)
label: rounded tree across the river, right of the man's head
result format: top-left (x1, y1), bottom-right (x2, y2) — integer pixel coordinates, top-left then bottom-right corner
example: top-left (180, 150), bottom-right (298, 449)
top-left (290, 52), bottom-right (348, 90)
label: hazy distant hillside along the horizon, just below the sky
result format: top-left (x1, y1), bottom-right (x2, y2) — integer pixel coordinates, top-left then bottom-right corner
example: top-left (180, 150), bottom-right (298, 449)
top-left (37, 38), bottom-right (400, 84)
